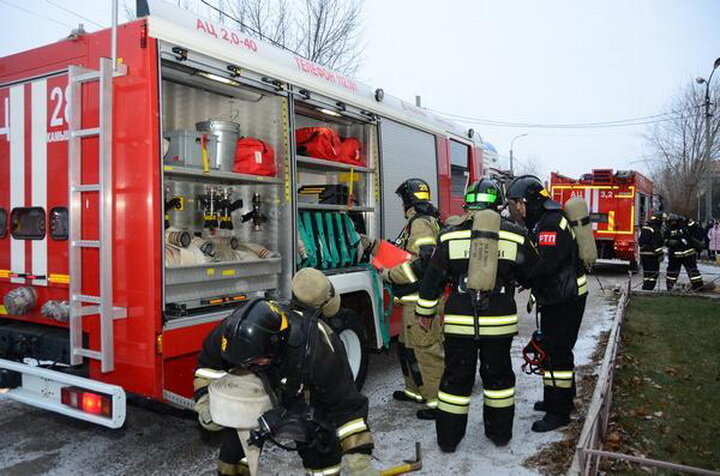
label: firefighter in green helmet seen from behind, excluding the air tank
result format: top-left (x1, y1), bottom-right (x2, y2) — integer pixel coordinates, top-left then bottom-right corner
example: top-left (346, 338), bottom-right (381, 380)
top-left (415, 178), bottom-right (538, 452)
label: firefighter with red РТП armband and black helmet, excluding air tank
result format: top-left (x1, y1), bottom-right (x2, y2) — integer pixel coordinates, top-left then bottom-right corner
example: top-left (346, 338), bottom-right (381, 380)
top-left (507, 175), bottom-right (588, 432)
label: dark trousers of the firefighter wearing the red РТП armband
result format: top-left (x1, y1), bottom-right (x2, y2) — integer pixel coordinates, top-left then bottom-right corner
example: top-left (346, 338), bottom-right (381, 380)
top-left (540, 294), bottom-right (587, 417)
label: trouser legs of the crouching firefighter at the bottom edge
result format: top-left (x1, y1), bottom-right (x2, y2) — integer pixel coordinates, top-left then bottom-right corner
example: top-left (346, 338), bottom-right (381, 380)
top-left (217, 428), bottom-right (342, 476)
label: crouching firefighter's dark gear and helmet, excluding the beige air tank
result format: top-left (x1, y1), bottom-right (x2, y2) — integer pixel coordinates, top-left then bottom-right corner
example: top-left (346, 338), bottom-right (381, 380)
top-left (194, 288), bottom-right (377, 475)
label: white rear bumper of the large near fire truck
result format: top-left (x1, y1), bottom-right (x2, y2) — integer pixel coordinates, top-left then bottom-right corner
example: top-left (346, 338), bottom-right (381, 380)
top-left (0, 359), bottom-right (126, 428)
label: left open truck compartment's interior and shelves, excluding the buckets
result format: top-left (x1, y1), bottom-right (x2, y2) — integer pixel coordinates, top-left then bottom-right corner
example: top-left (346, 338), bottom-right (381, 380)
top-left (161, 61), bottom-right (292, 319)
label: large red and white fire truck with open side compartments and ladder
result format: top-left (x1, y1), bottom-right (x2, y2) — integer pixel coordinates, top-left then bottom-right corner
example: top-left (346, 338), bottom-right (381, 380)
top-left (0, 0), bottom-right (482, 428)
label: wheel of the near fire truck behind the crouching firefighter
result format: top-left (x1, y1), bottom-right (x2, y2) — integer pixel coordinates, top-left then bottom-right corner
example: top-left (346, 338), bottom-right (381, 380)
top-left (329, 311), bottom-right (370, 390)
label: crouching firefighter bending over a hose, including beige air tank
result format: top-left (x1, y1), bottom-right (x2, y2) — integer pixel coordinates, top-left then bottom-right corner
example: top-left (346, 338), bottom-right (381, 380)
top-left (194, 269), bottom-right (379, 475)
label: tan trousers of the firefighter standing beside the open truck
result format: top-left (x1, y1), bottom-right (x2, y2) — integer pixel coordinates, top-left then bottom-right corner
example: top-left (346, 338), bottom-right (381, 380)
top-left (398, 302), bottom-right (444, 407)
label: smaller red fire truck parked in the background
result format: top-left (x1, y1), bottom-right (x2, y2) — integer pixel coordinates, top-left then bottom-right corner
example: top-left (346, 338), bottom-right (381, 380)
top-left (550, 169), bottom-right (653, 269)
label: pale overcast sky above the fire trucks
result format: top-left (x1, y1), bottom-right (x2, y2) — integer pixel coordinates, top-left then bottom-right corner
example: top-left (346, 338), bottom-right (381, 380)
top-left (0, 0), bottom-right (720, 179)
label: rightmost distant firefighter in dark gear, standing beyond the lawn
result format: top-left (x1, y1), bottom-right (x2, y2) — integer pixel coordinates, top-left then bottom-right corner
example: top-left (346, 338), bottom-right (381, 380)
top-left (665, 214), bottom-right (703, 291)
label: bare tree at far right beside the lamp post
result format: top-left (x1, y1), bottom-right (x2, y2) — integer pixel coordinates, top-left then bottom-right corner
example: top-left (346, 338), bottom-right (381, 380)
top-left (646, 83), bottom-right (720, 216)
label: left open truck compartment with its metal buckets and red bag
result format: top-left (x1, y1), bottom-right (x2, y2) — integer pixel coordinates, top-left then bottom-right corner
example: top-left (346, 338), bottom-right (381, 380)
top-left (162, 61), bottom-right (293, 319)
